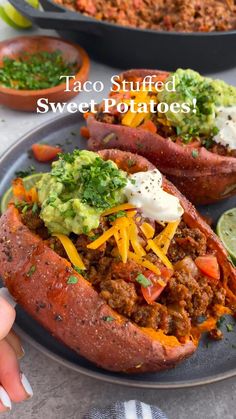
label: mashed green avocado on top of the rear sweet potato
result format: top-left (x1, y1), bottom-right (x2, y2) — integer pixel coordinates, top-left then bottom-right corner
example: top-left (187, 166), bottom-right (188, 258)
top-left (158, 69), bottom-right (236, 135)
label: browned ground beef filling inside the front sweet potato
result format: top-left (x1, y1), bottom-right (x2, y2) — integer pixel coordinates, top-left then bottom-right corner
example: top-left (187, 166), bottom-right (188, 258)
top-left (18, 208), bottom-right (229, 341)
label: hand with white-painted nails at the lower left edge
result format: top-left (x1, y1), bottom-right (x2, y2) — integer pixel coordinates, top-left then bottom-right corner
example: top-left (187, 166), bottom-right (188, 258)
top-left (0, 296), bottom-right (33, 412)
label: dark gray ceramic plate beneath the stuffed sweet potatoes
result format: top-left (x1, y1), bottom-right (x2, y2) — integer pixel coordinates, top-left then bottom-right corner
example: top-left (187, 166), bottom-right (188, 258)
top-left (0, 114), bottom-right (236, 388)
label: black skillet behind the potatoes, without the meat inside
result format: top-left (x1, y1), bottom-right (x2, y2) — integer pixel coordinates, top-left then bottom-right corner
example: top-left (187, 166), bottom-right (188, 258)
top-left (9, 0), bottom-right (236, 73)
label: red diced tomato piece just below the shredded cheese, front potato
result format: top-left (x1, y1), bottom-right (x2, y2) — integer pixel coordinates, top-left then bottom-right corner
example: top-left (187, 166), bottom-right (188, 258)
top-left (141, 266), bottom-right (172, 304)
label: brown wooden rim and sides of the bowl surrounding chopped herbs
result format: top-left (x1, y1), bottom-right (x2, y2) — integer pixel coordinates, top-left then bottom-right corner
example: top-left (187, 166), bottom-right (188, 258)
top-left (0, 36), bottom-right (90, 112)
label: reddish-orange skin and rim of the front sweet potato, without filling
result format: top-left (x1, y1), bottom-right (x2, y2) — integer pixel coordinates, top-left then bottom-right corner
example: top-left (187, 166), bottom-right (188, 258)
top-left (0, 150), bottom-right (236, 373)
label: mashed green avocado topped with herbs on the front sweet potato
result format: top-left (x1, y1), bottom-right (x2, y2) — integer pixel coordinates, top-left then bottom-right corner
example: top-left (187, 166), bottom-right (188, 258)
top-left (37, 150), bottom-right (127, 235)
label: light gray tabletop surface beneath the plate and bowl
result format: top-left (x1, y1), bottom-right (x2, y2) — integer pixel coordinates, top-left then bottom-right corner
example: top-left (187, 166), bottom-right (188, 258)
top-left (0, 21), bottom-right (236, 419)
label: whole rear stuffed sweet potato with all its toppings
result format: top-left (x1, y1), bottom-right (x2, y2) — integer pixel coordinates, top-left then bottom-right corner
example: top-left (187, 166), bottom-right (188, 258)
top-left (87, 69), bottom-right (236, 204)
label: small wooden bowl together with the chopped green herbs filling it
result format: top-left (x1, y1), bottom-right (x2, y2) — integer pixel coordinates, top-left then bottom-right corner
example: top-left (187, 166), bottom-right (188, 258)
top-left (0, 35), bottom-right (90, 113)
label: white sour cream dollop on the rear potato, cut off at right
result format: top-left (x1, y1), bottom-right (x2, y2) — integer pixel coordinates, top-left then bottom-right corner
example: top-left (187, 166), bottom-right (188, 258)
top-left (213, 106), bottom-right (236, 150)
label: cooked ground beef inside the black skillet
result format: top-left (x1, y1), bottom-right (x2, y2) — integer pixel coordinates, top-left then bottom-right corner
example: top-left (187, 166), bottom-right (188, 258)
top-left (54, 0), bottom-right (236, 32)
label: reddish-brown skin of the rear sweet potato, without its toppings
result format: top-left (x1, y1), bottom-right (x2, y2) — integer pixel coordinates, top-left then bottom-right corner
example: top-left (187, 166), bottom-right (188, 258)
top-left (87, 70), bottom-right (236, 205)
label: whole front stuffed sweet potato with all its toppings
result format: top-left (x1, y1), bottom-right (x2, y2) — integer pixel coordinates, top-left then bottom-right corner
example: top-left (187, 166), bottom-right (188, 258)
top-left (0, 150), bottom-right (236, 372)
